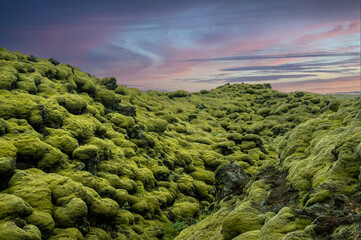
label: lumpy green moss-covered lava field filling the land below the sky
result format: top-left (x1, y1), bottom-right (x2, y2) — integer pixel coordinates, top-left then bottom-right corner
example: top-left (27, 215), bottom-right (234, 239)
top-left (0, 48), bottom-right (361, 240)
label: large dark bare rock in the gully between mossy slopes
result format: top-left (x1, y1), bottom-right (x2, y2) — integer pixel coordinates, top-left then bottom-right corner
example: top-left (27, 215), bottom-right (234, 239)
top-left (214, 162), bottom-right (250, 201)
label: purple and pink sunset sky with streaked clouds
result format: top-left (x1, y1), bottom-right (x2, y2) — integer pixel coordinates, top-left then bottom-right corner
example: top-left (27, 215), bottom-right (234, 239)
top-left (0, 0), bottom-right (361, 93)
